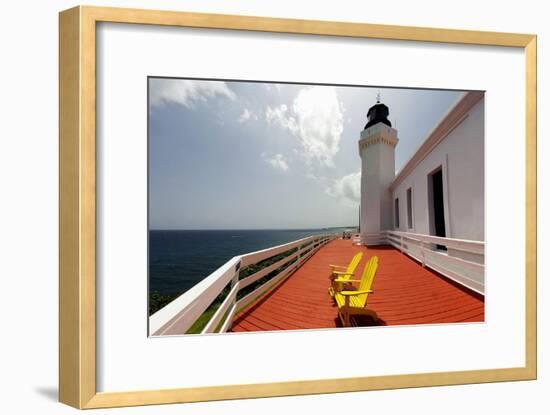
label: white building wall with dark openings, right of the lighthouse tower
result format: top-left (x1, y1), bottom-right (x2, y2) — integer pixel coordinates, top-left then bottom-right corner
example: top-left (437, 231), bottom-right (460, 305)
top-left (392, 98), bottom-right (485, 241)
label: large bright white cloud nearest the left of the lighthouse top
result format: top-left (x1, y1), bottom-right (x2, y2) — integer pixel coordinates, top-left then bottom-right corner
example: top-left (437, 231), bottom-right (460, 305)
top-left (265, 86), bottom-right (344, 167)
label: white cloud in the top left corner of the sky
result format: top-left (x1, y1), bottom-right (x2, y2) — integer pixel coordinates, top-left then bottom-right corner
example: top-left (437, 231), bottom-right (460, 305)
top-left (149, 79), bottom-right (237, 108)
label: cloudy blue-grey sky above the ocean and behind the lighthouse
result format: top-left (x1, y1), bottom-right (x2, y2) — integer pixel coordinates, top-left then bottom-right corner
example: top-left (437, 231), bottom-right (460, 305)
top-left (148, 78), bottom-right (463, 229)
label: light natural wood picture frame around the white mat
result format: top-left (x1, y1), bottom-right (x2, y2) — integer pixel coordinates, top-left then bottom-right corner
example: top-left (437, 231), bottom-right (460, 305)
top-left (59, 6), bottom-right (537, 408)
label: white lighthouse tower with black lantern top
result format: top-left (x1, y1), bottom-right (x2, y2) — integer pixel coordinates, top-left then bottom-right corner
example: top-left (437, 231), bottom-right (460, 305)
top-left (359, 95), bottom-right (399, 245)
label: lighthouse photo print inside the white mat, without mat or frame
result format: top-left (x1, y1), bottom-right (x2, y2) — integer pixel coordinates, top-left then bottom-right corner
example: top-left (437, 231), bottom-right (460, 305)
top-left (148, 81), bottom-right (485, 336)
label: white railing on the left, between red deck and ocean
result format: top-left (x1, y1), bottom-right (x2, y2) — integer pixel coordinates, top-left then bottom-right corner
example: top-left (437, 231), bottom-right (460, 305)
top-left (149, 234), bottom-right (337, 336)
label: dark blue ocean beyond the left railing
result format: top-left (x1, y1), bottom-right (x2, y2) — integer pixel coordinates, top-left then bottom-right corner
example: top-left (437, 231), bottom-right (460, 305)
top-left (149, 228), bottom-right (343, 295)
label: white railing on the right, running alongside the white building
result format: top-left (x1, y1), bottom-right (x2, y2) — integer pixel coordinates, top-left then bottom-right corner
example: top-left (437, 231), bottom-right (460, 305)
top-left (383, 231), bottom-right (485, 295)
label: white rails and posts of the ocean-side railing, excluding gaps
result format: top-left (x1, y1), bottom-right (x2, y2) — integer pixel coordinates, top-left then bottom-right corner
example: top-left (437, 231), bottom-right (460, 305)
top-left (149, 234), bottom-right (335, 335)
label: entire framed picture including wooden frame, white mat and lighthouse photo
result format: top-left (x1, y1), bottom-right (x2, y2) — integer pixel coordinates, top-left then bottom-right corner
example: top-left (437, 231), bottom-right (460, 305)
top-left (59, 7), bottom-right (536, 408)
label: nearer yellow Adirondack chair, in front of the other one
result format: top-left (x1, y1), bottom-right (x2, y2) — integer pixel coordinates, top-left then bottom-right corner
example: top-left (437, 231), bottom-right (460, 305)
top-left (334, 256), bottom-right (378, 327)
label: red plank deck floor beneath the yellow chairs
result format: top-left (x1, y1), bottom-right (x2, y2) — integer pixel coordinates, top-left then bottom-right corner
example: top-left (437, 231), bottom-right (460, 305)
top-left (231, 239), bottom-right (485, 332)
